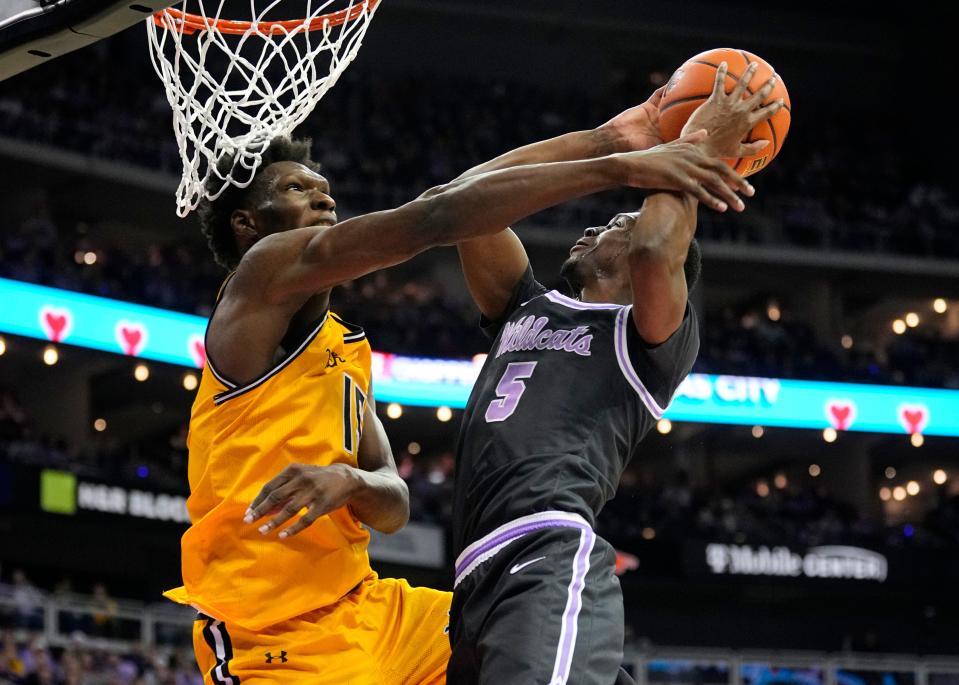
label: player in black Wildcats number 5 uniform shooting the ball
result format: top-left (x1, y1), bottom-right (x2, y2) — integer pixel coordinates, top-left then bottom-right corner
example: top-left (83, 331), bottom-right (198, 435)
top-left (448, 65), bottom-right (781, 685)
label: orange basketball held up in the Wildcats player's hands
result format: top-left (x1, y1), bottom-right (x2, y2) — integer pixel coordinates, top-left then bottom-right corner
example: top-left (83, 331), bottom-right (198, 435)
top-left (659, 48), bottom-right (792, 176)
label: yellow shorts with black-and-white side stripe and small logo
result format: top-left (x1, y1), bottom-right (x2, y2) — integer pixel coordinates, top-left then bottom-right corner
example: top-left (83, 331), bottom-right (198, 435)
top-left (193, 574), bottom-right (452, 685)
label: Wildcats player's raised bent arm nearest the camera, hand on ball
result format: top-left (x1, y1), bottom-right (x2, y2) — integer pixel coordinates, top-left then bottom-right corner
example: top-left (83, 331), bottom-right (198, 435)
top-left (622, 62), bottom-right (782, 345)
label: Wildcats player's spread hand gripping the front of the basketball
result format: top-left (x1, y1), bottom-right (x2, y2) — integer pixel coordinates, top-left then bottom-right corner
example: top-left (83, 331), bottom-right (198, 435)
top-left (680, 62), bottom-right (783, 159)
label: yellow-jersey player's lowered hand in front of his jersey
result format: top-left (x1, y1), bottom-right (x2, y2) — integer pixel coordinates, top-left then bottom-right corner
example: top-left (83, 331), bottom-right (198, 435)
top-left (243, 464), bottom-right (357, 538)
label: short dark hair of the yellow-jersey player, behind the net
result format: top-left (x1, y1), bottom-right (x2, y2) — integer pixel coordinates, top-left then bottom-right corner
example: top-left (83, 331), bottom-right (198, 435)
top-left (197, 136), bottom-right (320, 270)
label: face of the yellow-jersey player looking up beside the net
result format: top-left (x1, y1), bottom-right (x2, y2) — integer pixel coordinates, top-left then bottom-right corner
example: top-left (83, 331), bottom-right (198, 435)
top-left (256, 162), bottom-right (336, 237)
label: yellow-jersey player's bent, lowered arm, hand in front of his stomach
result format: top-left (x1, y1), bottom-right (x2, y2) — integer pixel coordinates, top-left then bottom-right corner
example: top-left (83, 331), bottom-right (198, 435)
top-left (244, 398), bottom-right (410, 538)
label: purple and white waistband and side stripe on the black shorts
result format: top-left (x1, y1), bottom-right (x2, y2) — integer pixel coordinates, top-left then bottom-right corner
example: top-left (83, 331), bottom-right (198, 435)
top-left (453, 511), bottom-right (596, 685)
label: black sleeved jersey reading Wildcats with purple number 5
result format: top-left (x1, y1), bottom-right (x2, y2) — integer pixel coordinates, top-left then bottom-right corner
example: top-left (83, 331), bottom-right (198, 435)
top-left (453, 269), bottom-right (699, 554)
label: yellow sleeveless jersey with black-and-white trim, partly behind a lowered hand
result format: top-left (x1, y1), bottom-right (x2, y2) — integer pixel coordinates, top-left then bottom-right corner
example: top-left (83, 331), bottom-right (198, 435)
top-left (165, 300), bottom-right (372, 631)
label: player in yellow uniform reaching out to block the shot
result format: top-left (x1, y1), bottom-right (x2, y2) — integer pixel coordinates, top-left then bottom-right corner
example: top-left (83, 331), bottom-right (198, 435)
top-left (167, 132), bottom-right (750, 685)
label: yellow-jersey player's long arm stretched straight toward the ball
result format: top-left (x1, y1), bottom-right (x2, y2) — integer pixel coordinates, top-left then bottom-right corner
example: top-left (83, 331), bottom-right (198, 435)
top-left (246, 147), bottom-right (748, 307)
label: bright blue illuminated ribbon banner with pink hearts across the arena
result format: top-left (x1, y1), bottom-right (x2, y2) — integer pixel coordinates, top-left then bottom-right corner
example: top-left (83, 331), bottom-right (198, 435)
top-left (0, 279), bottom-right (959, 436)
